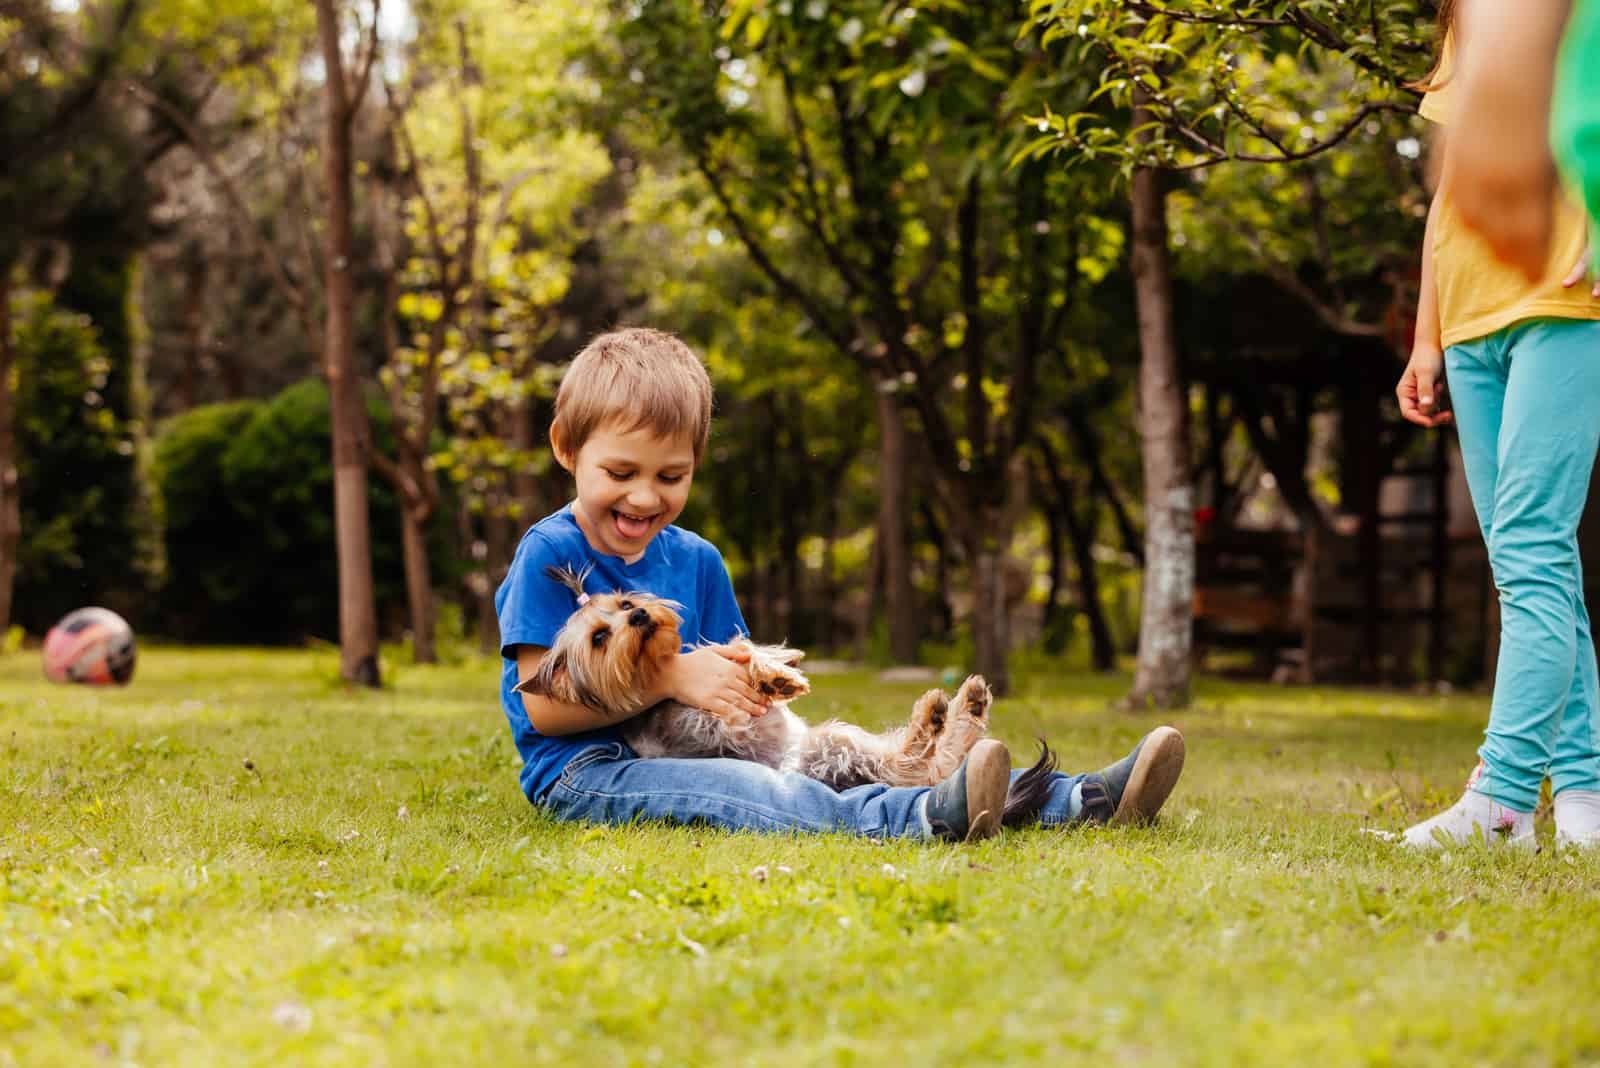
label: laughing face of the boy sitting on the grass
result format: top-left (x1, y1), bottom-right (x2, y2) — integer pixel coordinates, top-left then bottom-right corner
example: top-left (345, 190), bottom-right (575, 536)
top-left (550, 424), bottom-right (694, 563)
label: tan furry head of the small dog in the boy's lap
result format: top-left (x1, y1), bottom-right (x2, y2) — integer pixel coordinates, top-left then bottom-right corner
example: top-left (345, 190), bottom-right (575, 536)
top-left (517, 579), bottom-right (683, 718)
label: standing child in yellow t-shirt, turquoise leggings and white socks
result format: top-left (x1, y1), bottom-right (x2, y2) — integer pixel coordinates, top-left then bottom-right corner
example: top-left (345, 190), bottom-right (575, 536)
top-left (1395, 0), bottom-right (1600, 849)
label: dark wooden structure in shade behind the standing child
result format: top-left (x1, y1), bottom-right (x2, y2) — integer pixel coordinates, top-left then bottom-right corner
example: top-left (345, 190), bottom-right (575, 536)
top-left (1189, 321), bottom-right (1498, 683)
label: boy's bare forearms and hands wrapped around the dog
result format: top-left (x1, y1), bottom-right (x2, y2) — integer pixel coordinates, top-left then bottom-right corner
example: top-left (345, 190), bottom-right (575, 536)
top-left (517, 646), bottom-right (768, 737)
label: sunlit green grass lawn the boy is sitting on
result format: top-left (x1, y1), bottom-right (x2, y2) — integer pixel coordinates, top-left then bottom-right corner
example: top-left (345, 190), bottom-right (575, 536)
top-left (0, 649), bottom-right (1600, 1066)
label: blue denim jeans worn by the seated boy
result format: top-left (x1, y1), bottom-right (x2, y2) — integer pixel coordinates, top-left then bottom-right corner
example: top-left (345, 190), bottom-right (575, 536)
top-left (536, 742), bottom-right (1083, 838)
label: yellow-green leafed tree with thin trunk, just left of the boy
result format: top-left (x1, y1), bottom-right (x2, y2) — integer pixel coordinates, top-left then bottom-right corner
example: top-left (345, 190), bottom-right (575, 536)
top-left (373, 5), bottom-right (606, 664)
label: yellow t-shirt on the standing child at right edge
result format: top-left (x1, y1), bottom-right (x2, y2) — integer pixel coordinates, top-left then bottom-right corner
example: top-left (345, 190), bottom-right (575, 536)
top-left (1421, 40), bottom-right (1600, 345)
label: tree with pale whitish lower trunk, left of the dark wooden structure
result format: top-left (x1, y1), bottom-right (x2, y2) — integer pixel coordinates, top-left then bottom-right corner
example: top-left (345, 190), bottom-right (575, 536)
top-left (1018, 0), bottom-right (1424, 705)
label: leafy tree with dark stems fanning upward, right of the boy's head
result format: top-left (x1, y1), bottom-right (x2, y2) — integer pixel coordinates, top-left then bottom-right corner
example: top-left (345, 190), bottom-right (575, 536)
top-left (619, 0), bottom-right (1120, 687)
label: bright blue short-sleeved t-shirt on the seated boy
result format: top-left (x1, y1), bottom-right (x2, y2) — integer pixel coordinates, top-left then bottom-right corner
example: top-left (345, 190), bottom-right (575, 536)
top-left (494, 505), bottom-right (749, 801)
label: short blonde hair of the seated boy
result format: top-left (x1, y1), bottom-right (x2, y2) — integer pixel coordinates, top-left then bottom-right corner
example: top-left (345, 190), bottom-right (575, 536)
top-left (550, 326), bottom-right (710, 465)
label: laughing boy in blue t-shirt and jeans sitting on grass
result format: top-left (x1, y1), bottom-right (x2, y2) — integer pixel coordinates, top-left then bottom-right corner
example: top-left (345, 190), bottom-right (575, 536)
top-left (494, 329), bottom-right (1184, 841)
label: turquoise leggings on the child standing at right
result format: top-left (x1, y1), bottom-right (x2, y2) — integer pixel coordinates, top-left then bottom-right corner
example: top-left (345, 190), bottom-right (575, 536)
top-left (1445, 318), bottom-right (1600, 812)
